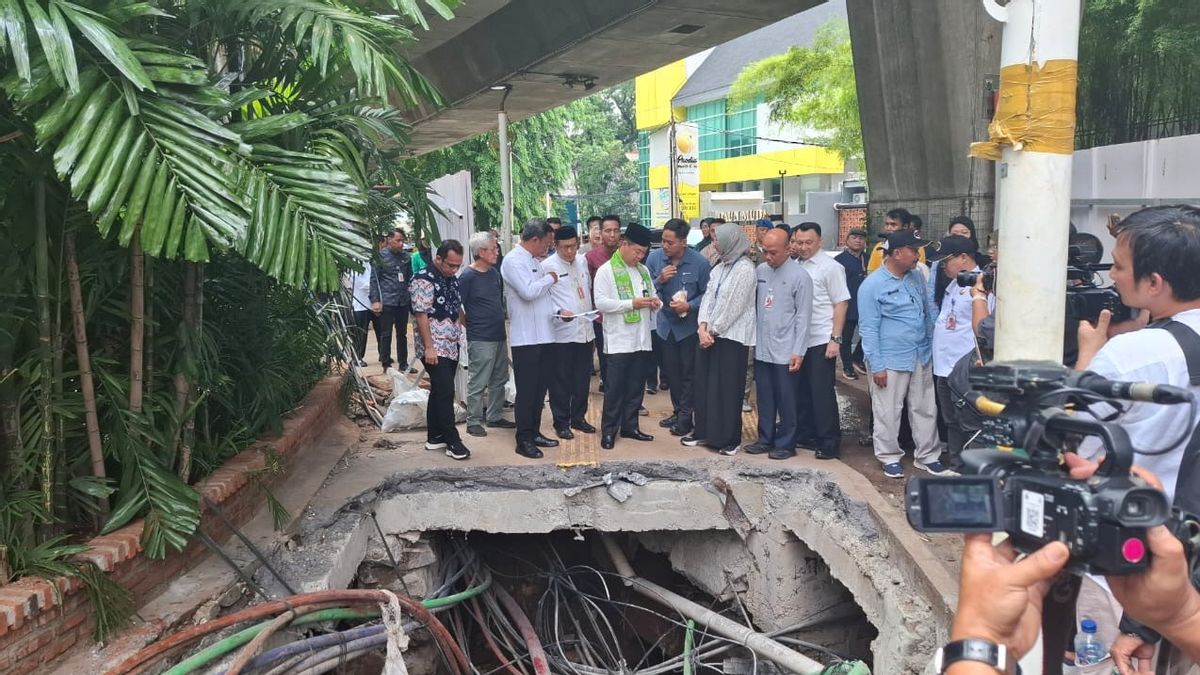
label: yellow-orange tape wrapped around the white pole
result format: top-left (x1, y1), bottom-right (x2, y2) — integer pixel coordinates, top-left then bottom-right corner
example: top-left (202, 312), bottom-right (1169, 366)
top-left (971, 59), bottom-right (1079, 160)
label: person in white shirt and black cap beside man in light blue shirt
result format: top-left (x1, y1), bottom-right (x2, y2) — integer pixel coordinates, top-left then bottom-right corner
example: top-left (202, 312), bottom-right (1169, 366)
top-left (930, 235), bottom-right (995, 458)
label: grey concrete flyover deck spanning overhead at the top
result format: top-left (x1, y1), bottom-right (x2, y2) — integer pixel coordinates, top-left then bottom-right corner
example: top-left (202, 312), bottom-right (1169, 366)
top-left (406, 0), bottom-right (824, 155)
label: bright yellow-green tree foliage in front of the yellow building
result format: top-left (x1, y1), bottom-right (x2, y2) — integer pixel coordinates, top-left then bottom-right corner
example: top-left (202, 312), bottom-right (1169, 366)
top-left (730, 19), bottom-right (864, 171)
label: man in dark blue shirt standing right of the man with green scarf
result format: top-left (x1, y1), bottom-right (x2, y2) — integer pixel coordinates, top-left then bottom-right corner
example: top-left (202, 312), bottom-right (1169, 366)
top-left (646, 219), bottom-right (712, 436)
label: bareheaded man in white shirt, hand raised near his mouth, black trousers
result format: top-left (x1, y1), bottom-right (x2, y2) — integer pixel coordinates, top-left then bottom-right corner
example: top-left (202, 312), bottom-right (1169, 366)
top-left (500, 219), bottom-right (558, 459)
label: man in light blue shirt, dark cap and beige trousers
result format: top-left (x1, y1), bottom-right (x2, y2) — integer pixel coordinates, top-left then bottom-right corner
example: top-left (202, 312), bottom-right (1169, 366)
top-left (858, 229), bottom-right (952, 478)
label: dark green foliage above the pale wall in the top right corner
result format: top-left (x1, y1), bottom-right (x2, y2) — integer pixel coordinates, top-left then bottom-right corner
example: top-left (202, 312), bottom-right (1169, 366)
top-left (1076, 0), bottom-right (1200, 148)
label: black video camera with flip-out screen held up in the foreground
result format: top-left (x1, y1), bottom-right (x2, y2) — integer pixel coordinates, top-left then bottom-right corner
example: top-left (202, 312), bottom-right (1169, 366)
top-left (905, 362), bottom-right (1200, 574)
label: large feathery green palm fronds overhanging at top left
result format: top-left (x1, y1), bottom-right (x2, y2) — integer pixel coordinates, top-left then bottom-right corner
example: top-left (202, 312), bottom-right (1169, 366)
top-left (0, 0), bottom-right (450, 291)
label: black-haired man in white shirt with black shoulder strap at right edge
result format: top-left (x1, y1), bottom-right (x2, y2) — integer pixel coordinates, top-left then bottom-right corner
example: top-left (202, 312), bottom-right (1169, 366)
top-left (1075, 205), bottom-right (1200, 674)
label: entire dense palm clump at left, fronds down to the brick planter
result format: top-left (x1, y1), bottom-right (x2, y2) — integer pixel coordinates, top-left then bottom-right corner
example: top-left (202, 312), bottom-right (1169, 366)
top-left (0, 0), bottom-right (458, 633)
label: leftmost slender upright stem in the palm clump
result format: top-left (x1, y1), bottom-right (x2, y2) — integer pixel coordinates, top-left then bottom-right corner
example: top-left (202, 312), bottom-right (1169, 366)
top-left (34, 178), bottom-right (55, 518)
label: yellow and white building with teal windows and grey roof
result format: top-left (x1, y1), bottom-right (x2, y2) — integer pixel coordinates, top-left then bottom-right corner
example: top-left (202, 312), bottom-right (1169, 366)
top-left (635, 2), bottom-right (845, 227)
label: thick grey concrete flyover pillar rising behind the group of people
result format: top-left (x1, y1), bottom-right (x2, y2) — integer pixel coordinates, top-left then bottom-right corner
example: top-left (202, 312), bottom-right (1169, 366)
top-left (846, 0), bottom-right (1001, 237)
